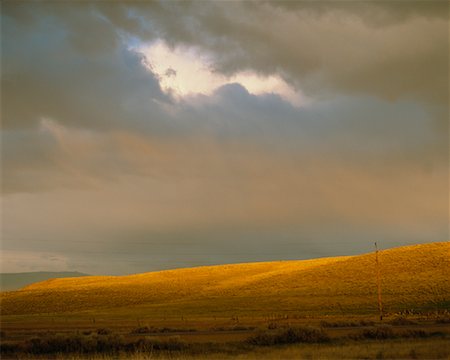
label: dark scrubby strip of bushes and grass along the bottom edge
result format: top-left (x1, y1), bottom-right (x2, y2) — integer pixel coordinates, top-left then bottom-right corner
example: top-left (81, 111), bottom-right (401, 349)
top-left (1, 317), bottom-right (450, 360)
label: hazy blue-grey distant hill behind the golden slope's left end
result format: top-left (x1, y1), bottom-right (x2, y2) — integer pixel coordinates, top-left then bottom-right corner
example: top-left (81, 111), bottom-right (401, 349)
top-left (0, 271), bottom-right (88, 291)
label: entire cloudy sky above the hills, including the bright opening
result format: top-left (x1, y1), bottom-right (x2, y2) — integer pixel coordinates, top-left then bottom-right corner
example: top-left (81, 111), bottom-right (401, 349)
top-left (1, 0), bottom-right (449, 275)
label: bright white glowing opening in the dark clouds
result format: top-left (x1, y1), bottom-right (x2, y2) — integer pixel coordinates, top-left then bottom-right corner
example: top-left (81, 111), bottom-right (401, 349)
top-left (138, 41), bottom-right (308, 106)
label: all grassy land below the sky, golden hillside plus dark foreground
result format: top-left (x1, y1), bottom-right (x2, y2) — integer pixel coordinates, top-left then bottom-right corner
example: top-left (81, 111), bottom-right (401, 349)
top-left (1, 242), bottom-right (450, 359)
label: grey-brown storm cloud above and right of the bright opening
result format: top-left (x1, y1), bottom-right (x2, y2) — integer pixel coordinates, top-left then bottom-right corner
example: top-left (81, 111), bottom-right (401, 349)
top-left (89, 1), bottom-right (448, 103)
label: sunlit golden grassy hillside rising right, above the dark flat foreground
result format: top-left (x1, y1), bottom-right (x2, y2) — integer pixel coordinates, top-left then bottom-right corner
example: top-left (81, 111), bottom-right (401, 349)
top-left (1, 242), bottom-right (450, 316)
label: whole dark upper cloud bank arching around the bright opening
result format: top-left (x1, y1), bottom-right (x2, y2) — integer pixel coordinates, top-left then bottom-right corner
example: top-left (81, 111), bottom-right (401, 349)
top-left (2, 1), bottom-right (448, 134)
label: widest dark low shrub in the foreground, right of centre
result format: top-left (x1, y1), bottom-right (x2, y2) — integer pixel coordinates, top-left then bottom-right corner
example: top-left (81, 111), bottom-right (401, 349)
top-left (247, 327), bottom-right (330, 346)
